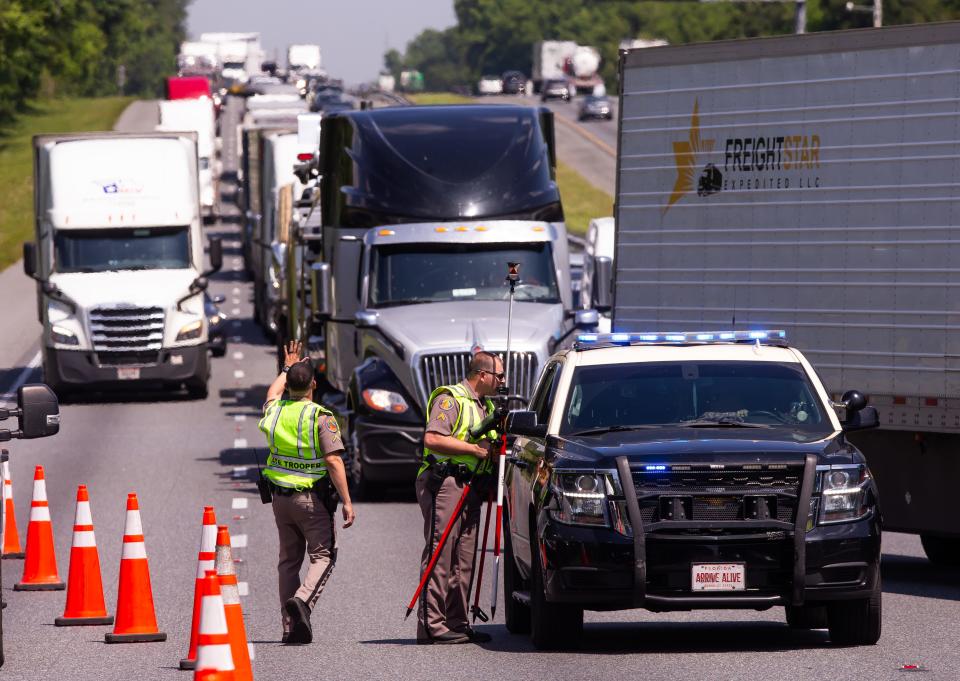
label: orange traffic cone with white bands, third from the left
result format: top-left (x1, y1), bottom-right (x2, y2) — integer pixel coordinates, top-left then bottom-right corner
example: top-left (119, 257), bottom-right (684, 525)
top-left (53, 485), bottom-right (113, 627)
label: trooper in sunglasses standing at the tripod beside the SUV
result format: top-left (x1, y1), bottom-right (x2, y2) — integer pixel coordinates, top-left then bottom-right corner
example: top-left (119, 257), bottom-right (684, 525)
top-left (416, 350), bottom-right (504, 645)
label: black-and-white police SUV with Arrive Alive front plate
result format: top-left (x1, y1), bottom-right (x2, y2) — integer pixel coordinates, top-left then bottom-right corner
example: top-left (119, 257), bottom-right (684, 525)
top-left (504, 331), bottom-right (881, 648)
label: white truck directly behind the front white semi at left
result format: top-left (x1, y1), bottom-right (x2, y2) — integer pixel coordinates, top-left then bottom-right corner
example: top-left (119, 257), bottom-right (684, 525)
top-left (157, 97), bottom-right (220, 222)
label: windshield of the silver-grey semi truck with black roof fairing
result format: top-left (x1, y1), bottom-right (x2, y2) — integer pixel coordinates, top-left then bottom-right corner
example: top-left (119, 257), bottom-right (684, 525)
top-left (370, 243), bottom-right (560, 307)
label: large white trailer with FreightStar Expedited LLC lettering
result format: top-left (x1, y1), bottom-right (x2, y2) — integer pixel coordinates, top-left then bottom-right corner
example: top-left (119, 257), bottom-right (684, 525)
top-left (613, 23), bottom-right (960, 563)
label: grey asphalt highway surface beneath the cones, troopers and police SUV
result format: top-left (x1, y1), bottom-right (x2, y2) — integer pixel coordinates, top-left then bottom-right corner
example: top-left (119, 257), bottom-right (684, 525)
top-left (0, 101), bottom-right (960, 681)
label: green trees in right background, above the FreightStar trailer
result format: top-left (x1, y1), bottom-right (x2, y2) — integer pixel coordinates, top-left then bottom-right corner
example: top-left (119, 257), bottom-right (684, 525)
top-left (384, 0), bottom-right (960, 91)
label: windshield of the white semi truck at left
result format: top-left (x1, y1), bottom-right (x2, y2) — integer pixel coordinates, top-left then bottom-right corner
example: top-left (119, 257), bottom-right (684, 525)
top-left (54, 227), bottom-right (190, 272)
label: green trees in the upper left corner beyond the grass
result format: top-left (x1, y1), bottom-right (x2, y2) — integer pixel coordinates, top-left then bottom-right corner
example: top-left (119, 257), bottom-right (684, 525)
top-left (0, 0), bottom-right (189, 121)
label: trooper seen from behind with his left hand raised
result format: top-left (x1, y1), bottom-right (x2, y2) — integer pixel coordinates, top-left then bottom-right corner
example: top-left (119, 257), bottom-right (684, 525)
top-left (260, 341), bottom-right (356, 643)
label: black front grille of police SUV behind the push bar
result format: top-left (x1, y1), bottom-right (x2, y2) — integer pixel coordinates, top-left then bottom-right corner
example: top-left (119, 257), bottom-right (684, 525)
top-left (633, 464), bottom-right (803, 524)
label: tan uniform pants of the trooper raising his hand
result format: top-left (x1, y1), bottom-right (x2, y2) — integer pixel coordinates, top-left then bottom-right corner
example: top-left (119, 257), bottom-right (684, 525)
top-left (273, 491), bottom-right (337, 631)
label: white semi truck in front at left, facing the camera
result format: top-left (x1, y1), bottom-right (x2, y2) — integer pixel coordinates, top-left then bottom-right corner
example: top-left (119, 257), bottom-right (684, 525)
top-left (23, 132), bottom-right (222, 397)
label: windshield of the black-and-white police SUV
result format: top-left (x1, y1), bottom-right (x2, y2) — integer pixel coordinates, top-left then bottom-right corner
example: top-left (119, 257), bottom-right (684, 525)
top-left (560, 362), bottom-right (833, 435)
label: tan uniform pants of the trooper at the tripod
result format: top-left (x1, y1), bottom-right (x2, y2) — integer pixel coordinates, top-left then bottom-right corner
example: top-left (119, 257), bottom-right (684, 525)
top-left (416, 471), bottom-right (482, 639)
